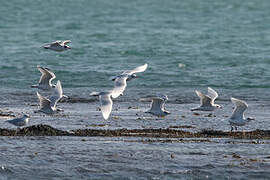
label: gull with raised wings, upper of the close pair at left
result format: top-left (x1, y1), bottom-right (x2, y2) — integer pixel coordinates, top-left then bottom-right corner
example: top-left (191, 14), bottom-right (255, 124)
top-left (31, 66), bottom-right (56, 91)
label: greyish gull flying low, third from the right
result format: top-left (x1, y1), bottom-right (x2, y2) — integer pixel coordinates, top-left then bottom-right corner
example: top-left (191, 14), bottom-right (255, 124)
top-left (145, 95), bottom-right (171, 117)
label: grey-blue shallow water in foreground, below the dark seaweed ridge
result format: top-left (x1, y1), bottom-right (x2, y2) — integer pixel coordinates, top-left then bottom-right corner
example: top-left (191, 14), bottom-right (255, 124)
top-left (0, 137), bottom-right (270, 179)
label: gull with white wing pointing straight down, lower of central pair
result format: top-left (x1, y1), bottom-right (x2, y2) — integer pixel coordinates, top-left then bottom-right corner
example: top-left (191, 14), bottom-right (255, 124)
top-left (90, 91), bottom-right (113, 120)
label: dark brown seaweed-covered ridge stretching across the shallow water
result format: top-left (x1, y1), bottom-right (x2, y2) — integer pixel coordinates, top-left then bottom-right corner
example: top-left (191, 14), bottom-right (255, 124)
top-left (0, 124), bottom-right (270, 139)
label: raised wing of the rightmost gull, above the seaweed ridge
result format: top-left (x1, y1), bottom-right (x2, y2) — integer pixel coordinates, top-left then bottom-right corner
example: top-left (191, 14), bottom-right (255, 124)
top-left (231, 97), bottom-right (248, 119)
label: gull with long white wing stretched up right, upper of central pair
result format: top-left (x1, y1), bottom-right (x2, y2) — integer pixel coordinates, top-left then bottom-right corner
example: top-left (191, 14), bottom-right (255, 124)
top-left (112, 64), bottom-right (148, 98)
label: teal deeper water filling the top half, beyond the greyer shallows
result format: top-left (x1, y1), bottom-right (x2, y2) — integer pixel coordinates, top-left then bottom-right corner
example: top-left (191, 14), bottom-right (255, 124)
top-left (0, 0), bottom-right (270, 93)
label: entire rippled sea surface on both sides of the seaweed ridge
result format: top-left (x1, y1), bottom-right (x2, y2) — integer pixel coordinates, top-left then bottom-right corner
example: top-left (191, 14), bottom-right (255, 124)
top-left (0, 0), bottom-right (270, 179)
